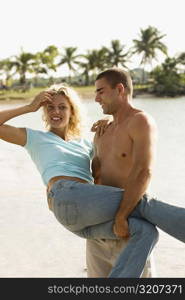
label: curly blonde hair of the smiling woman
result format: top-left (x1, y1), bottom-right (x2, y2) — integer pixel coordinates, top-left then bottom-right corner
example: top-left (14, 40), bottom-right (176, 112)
top-left (43, 83), bottom-right (85, 138)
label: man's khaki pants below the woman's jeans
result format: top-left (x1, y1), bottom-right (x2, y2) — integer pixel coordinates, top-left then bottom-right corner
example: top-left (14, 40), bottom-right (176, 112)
top-left (86, 239), bottom-right (156, 278)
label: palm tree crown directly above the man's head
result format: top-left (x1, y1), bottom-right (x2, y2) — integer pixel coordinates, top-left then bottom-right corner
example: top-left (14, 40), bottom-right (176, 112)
top-left (107, 40), bottom-right (130, 69)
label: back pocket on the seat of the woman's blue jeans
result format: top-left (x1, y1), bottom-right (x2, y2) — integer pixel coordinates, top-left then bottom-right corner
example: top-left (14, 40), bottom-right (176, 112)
top-left (55, 202), bottom-right (78, 226)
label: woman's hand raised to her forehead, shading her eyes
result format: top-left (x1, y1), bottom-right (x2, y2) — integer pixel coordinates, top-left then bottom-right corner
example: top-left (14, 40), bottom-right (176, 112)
top-left (29, 91), bottom-right (56, 112)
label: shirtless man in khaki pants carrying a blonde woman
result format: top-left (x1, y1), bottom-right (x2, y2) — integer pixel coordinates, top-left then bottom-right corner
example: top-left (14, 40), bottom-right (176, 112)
top-left (86, 68), bottom-right (156, 277)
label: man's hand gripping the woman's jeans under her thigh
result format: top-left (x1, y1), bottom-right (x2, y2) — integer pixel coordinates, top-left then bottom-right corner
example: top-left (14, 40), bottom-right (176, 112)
top-left (113, 215), bottom-right (130, 238)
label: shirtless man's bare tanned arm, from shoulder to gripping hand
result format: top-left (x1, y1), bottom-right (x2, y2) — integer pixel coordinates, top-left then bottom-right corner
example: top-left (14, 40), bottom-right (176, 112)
top-left (114, 113), bottom-right (156, 237)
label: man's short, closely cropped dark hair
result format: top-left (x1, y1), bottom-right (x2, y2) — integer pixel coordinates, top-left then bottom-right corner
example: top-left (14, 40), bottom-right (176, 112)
top-left (96, 68), bottom-right (133, 96)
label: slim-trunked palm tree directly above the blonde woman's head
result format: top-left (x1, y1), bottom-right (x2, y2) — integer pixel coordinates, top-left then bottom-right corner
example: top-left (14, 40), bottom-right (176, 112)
top-left (58, 47), bottom-right (81, 81)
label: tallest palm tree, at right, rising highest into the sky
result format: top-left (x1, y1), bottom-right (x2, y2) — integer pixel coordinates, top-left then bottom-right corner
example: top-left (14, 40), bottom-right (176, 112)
top-left (132, 26), bottom-right (167, 81)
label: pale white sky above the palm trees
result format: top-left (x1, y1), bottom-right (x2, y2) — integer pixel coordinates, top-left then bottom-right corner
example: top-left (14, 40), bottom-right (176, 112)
top-left (0, 0), bottom-right (185, 71)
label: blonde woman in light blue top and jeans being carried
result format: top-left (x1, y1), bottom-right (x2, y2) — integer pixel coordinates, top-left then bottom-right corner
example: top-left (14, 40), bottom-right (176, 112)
top-left (0, 85), bottom-right (185, 278)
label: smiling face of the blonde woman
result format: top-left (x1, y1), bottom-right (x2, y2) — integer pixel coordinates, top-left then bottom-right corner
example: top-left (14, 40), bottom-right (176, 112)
top-left (45, 95), bottom-right (71, 129)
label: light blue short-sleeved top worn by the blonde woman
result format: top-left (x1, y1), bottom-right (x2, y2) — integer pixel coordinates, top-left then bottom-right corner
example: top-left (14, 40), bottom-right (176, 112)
top-left (24, 128), bottom-right (93, 185)
